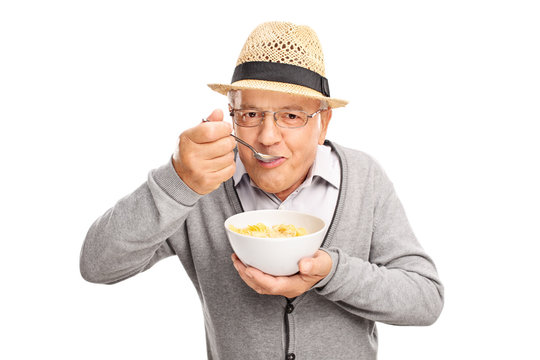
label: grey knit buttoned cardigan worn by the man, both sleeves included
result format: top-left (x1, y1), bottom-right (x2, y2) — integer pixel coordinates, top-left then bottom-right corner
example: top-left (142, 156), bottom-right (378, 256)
top-left (80, 141), bottom-right (443, 360)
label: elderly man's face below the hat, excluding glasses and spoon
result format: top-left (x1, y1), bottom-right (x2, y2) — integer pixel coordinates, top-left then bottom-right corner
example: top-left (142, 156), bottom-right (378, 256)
top-left (231, 90), bottom-right (332, 200)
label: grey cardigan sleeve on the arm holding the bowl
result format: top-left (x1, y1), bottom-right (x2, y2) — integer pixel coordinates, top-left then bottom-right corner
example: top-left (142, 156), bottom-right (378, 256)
top-left (315, 160), bottom-right (444, 325)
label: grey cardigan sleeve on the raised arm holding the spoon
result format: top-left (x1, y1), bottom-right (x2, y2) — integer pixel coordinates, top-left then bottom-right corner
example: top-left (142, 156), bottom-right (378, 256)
top-left (80, 161), bottom-right (201, 284)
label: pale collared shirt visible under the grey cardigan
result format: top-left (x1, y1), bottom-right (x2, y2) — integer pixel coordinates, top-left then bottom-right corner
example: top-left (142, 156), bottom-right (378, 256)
top-left (233, 145), bottom-right (341, 231)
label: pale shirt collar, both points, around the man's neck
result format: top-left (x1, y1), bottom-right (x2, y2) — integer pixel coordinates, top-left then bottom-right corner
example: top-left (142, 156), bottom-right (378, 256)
top-left (233, 145), bottom-right (340, 188)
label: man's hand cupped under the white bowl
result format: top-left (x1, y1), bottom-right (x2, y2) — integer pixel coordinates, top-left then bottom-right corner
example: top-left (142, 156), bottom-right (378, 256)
top-left (231, 250), bottom-right (332, 298)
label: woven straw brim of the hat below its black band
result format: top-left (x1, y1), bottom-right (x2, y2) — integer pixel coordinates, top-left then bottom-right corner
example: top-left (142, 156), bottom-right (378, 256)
top-left (208, 80), bottom-right (349, 109)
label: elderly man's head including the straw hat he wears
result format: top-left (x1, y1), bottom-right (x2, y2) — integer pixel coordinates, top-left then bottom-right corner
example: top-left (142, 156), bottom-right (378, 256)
top-left (208, 22), bottom-right (347, 200)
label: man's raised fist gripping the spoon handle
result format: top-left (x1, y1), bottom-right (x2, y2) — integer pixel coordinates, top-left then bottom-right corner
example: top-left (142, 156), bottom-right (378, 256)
top-left (173, 109), bottom-right (236, 195)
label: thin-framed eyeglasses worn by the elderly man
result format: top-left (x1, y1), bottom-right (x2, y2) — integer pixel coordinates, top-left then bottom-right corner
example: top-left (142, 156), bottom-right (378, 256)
top-left (230, 109), bottom-right (325, 129)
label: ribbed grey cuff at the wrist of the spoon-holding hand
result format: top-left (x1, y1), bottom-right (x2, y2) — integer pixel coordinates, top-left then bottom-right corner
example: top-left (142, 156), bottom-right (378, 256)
top-left (151, 158), bottom-right (203, 206)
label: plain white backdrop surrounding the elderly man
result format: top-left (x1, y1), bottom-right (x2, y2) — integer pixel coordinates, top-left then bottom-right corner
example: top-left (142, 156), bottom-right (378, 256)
top-left (0, 0), bottom-right (540, 359)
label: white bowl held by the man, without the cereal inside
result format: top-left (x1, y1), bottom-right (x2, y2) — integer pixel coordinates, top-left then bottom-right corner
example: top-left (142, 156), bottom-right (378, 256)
top-left (224, 210), bottom-right (326, 276)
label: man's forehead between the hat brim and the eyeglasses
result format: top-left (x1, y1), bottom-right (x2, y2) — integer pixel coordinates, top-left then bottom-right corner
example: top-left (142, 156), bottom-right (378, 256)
top-left (229, 90), bottom-right (322, 111)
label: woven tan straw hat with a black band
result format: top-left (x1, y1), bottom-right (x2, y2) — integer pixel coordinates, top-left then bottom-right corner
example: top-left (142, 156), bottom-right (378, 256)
top-left (208, 22), bottom-right (348, 108)
